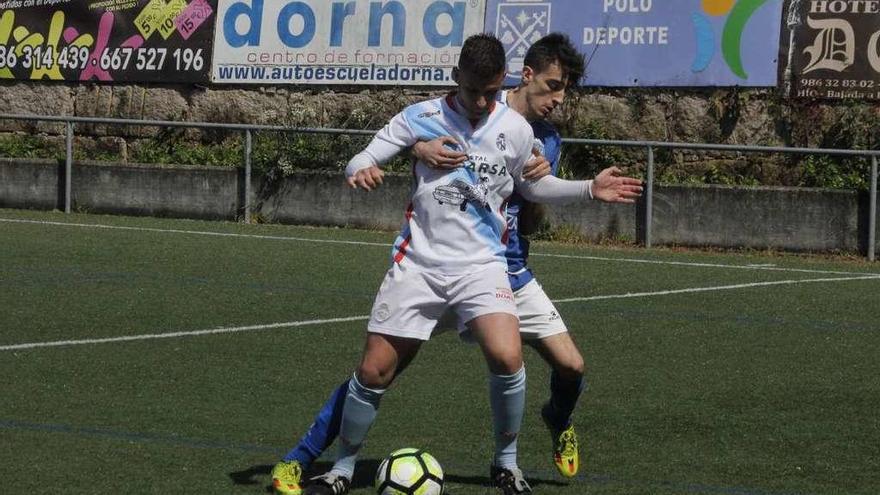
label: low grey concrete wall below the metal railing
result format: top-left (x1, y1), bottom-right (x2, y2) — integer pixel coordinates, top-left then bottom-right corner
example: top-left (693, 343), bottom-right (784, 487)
top-left (0, 159), bottom-right (869, 258)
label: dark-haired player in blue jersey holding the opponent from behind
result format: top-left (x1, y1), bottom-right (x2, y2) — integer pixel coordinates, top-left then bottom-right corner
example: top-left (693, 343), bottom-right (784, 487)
top-left (273, 35), bottom-right (641, 494)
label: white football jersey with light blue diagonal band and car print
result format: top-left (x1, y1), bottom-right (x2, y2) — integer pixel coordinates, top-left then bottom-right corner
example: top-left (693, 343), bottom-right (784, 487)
top-left (346, 96), bottom-right (534, 274)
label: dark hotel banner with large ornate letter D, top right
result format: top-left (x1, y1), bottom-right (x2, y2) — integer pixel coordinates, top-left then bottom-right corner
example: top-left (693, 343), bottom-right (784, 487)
top-left (780, 0), bottom-right (880, 100)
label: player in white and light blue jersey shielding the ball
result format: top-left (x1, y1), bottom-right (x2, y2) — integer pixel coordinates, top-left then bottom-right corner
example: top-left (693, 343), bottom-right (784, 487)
top-left (292, 34), bottom-right (590, 495)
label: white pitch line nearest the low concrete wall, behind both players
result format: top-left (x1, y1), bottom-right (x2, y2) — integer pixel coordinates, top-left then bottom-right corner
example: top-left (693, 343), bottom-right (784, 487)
top-left (0, 218), bottom-right (880, 276)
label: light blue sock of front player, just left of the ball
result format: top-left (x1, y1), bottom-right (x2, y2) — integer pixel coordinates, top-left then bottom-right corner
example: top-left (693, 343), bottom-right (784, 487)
top-left (331, 375), bottom-right (385, 480)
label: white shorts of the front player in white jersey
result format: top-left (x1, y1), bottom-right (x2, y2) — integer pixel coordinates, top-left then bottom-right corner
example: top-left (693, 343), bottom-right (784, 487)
top-left (367, 263), bottom-right (517, 340)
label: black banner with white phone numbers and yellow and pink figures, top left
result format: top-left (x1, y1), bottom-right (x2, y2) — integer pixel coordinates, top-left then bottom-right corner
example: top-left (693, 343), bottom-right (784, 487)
top-left (0, 0), bottom-right (217, 82)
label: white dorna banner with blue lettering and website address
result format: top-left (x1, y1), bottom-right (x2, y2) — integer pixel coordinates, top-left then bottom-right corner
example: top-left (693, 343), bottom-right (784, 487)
top-left (212, 0), bottom-right (486, 86)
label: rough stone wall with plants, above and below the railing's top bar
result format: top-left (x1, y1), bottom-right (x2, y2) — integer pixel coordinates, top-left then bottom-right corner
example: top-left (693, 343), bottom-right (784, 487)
top-left (0, 81), bottom-right (880, 189)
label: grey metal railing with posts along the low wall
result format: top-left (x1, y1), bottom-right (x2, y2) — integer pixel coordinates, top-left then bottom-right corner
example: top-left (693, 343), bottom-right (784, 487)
top-left (0, 114), bottom-right (880, 261)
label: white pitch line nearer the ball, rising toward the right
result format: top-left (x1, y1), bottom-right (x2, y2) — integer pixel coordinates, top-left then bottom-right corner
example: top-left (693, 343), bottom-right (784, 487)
top-left (0, 275), bottom-right (880, 352)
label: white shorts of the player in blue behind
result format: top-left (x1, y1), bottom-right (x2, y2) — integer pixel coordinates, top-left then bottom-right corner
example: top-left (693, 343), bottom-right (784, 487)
top-left (437, 279), bottom-right (568, 342)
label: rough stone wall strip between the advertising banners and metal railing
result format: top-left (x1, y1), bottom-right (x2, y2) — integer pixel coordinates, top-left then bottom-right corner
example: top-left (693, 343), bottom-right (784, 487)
top-left (0, 81), bottom-right (868, 146)
